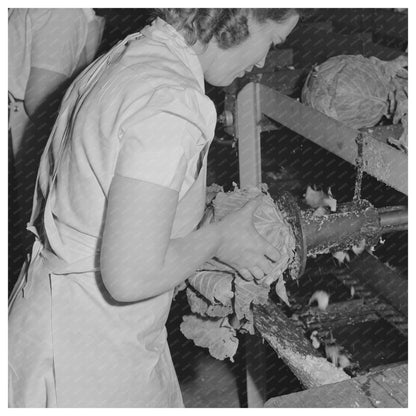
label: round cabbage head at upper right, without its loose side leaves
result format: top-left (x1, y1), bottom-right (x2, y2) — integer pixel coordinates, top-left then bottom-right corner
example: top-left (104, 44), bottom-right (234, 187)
top-left (302, 55), bottom-right (391, 129)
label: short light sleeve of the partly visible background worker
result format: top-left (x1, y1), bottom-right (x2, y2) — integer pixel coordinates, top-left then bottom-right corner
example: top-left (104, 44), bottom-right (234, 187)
top-left (30, 9), bottom-right (88, 78)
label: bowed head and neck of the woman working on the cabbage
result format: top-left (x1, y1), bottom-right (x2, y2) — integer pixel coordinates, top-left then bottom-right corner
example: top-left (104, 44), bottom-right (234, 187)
top-left (154, 9), bottom-right (299, 86)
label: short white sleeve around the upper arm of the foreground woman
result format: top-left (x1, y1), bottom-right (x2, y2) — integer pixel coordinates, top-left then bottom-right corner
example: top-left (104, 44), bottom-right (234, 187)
top-left (115, 113), bottom-right (195, 192)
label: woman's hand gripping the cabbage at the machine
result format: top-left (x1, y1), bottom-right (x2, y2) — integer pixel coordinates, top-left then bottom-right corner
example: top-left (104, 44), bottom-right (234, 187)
top-left (216, 196), bottom-right (280, 280)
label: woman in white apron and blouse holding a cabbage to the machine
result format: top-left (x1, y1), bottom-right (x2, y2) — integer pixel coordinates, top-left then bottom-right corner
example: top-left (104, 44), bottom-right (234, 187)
top-left (9, 9), bottom-right (298, 407)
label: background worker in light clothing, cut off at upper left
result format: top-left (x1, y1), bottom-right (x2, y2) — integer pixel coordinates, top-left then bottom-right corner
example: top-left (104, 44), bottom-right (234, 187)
top-left (8, 9), bottom-right (104, 158)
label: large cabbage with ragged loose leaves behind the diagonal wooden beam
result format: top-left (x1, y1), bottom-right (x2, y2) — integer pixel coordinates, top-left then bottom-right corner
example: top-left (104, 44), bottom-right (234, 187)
top-left (302, 55), bottom-right (408, 151)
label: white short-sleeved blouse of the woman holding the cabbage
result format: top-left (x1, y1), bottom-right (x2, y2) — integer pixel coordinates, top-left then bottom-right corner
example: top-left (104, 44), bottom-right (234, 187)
top-left (49, 19), bottom-right (216, 261)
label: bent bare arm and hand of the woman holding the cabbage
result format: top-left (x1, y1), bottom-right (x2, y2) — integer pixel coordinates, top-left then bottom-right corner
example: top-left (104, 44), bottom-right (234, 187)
top-left (101, 176), bottom-right (278, 302)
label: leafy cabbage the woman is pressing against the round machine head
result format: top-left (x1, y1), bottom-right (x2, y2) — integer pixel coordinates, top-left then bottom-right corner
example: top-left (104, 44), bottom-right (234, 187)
top-left (181, 188), bottom-right (295, 360)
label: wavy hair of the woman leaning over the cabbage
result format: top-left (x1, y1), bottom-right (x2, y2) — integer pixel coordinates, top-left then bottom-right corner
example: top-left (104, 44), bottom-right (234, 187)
top-left (155, 9), bottom-right (299, 49)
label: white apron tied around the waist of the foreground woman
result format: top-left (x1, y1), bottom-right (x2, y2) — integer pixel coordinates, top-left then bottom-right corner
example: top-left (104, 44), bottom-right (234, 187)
top-left (9, 34), bottom-right (206, 407)
